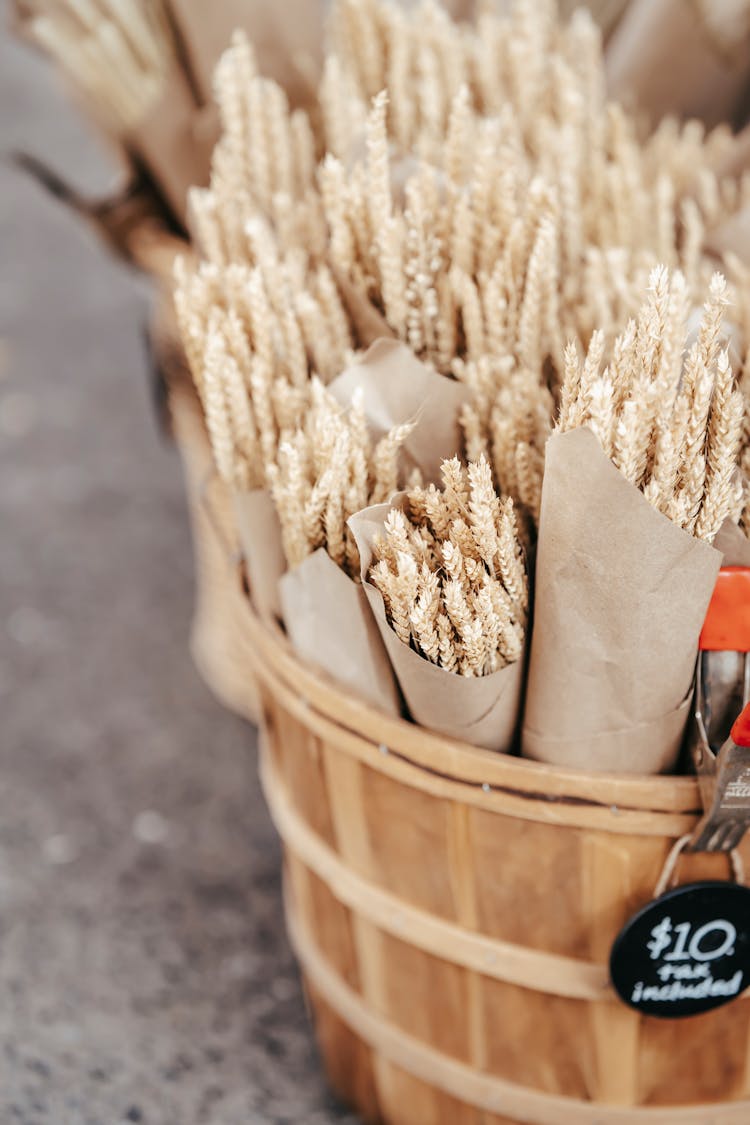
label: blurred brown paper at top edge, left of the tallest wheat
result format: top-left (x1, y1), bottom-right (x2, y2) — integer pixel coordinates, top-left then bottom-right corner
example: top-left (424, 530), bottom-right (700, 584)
top-left (169, 0), bottom-right (326, 106)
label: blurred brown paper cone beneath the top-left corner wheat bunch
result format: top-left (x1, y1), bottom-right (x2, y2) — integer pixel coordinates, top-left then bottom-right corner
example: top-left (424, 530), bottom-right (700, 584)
top-left (125, 68), bottom-right (218, 226)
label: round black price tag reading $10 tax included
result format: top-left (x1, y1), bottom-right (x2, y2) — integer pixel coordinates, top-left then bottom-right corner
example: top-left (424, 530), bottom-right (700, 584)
top-left (609, 882), bottom-right (750, 1019)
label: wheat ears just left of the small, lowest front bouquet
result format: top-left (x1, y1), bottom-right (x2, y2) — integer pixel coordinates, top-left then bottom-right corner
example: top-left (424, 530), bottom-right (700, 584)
top-left (266, 378), bottom-right (414, 581)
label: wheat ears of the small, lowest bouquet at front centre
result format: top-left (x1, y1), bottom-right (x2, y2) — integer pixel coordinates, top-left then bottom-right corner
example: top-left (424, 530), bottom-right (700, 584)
top-left (369, 458), bottom-right (528, 676)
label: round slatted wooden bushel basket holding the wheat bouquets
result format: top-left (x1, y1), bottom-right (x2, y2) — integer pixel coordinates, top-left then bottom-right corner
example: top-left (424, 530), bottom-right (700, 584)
top-left (235, 589), bottom-right (750, 1125)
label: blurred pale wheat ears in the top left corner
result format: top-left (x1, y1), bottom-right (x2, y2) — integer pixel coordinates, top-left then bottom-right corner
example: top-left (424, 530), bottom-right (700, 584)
top-left (19, 0), bottom-right (174, 133)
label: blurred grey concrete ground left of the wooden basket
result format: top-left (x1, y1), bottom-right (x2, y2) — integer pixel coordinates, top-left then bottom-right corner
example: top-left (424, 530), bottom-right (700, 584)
top-left (0, 10), bottom-right (352, 1125)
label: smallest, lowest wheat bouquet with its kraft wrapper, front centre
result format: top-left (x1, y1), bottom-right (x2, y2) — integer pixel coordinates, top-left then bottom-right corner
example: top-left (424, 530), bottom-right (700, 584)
top-left (350, 458), bottom-right (528, 750)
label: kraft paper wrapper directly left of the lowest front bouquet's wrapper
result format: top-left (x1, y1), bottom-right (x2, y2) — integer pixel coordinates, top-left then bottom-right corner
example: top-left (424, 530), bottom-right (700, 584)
top-left (280, 548), bottom-right (401, 716)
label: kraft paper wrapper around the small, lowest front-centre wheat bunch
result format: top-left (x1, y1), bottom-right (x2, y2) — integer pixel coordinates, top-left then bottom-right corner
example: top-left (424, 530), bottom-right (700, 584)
top-left (349, 493), bottom-right (524, 752)
